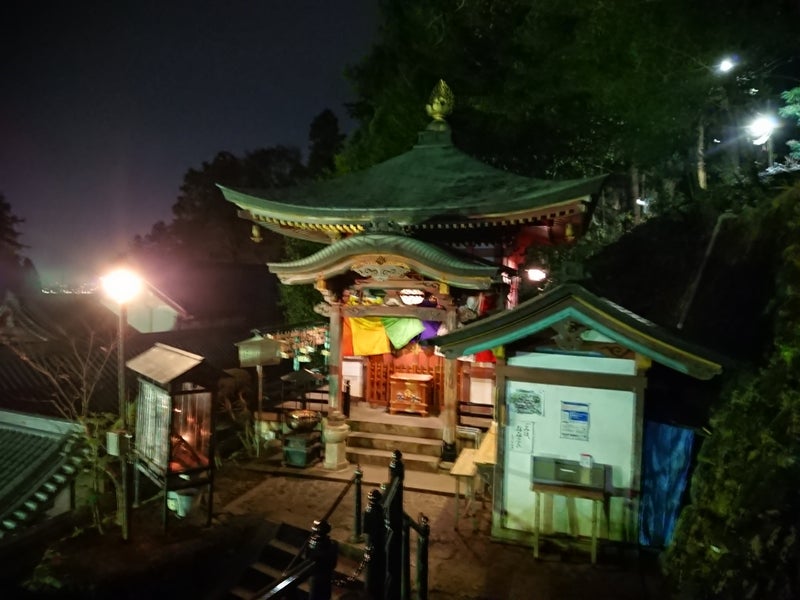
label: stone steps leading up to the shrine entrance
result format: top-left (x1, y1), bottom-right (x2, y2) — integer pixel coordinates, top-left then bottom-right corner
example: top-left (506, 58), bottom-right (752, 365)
top-left (347, 416), bottom-right (442, 473)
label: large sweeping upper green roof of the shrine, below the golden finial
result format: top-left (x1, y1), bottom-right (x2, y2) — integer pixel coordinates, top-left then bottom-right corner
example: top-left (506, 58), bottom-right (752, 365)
top-left (220, 131), bottom-right (605, 227)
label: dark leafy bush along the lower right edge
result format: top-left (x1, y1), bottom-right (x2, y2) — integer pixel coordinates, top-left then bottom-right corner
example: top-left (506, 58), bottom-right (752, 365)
top-left (665, 180), bottom-right (800, 599)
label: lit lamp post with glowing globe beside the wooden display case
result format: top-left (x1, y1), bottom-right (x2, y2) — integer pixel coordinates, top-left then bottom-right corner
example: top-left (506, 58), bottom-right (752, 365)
top-left (102, 269), bottom-right (142, 541)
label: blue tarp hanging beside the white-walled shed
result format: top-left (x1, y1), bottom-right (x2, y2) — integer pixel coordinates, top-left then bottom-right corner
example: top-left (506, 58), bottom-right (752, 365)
top-left (639, 422), bottom-right (694, 548)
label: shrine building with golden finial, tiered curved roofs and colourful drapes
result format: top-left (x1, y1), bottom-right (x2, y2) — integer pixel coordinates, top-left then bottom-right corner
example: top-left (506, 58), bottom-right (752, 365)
top-left (220, 81), bottom-right (605, 460)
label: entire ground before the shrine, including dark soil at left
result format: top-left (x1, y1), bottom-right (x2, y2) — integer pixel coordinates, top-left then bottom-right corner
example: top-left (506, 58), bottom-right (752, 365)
top-left (3, 461), bottom-right (669, 600)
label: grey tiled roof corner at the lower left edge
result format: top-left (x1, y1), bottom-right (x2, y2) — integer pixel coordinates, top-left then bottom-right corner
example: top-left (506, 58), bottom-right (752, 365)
top-left (0, 411), bottom-right (85, 539)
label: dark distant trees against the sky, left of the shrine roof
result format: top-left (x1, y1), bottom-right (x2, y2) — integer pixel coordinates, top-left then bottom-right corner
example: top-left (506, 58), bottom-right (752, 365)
top-left (134, 109), bottom-right (344, 330)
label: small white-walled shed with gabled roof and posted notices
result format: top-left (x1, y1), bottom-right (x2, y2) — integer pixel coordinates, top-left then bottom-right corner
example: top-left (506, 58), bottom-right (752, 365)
top-left (428, 284), bottom-right (722, 546)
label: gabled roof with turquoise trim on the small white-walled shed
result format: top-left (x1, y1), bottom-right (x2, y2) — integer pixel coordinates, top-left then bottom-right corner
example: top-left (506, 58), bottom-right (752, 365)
top-left (425, 284), bottom-right (722, 379)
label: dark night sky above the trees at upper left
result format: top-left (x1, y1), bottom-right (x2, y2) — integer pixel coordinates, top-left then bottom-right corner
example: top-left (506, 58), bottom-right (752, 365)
top-left (0, 0), bottom-right (378, 284)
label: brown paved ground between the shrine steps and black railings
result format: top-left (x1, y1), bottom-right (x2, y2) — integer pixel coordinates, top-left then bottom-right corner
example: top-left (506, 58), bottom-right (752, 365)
top-left (216, 458), bottom-right (669, 600)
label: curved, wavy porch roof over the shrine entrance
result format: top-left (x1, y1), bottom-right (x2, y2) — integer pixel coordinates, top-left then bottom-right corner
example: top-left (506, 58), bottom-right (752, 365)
top-left (268, 233), bottom-right (498, 289)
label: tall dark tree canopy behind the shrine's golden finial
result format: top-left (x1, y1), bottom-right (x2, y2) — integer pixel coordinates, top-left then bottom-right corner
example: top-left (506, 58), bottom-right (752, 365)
top-left (339, 0), bottom-right (798, 201)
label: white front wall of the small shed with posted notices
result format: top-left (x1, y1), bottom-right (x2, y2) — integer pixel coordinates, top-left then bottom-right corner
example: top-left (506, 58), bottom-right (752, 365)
top-left (501, 354), bottom-right (636, 540)
